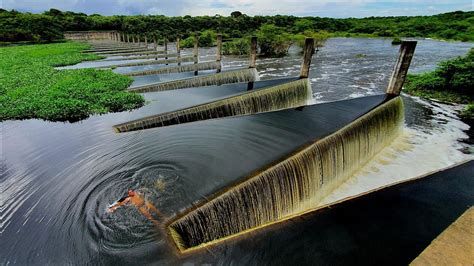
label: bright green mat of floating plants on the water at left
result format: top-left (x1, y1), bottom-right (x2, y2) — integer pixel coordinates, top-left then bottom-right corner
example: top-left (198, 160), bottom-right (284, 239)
top-left (0, 42), bottom-right (145, 122)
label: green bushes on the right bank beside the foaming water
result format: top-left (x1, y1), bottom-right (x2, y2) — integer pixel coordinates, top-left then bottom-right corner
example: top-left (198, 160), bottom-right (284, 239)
top-left (405, 48), bottom-right (474, 119)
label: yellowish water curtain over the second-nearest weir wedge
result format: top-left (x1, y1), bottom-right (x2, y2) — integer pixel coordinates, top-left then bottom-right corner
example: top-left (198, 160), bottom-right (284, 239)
top-left (114, 79), bottom-right (312, 132)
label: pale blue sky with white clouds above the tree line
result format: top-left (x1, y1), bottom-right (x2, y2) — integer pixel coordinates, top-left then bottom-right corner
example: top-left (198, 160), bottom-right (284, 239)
top-left (0, 0), bottom-right (473, 18)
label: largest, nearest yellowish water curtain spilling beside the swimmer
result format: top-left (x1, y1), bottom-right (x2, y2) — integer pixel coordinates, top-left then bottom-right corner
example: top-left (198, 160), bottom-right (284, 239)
top-left (168, 96), bottom-right (404, 252)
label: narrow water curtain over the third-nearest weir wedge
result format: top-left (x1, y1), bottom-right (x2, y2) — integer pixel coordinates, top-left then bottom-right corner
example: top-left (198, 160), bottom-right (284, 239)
top-left (128, 68), bottom-right (259, 93)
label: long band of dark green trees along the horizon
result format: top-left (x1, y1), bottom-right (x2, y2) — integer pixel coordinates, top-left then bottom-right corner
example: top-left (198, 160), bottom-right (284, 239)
top-left (0, 9), bottom-right (474, 43)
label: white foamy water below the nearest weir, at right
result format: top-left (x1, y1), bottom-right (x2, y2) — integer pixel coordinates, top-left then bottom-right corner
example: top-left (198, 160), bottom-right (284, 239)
top-left (319, 97), bottom-right (474, 206)
